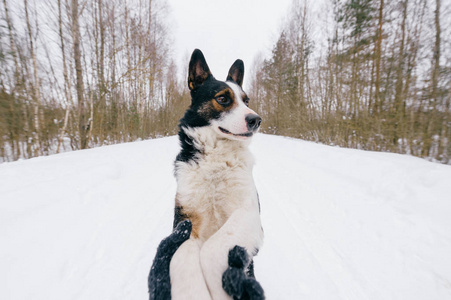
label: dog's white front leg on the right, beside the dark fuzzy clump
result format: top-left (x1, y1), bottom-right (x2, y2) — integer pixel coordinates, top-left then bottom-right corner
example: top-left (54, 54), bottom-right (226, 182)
top-left (200, 207), bottom-right (263, 300)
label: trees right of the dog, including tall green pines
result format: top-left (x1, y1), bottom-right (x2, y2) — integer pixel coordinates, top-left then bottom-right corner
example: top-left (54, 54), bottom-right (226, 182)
top-left (250, 0), bottom-right (451, 163)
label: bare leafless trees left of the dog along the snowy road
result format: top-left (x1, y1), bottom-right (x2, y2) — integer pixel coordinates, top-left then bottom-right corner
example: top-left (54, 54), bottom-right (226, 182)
top-left (0, 0), bottom-right (188, 161)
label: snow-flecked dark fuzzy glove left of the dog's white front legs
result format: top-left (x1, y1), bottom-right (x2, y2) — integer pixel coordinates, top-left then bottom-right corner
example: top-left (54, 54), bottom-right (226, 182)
top-left (147, 220), bottom-right (192, 300)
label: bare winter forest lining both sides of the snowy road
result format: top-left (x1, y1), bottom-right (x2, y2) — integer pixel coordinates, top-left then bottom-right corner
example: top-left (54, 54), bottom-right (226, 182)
top-left (0, 0), bottom-right (451, 164)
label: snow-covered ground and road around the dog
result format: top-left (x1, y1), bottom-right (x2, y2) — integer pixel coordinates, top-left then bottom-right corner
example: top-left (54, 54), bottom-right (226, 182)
top-left (0, 135), bottom-right (451, 300)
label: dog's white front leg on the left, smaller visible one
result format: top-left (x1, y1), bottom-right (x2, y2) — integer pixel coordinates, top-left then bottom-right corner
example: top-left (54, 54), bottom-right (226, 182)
top-left (170, 238), bottom-right (211, 300)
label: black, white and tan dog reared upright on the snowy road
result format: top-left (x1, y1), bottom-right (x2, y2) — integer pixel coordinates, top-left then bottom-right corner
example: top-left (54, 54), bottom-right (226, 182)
top-left (148, 49), bottom-right (264, 300)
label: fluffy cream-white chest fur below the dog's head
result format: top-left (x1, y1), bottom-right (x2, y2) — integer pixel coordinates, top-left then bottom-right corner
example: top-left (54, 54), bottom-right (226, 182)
top-left (176, 128), bottom-right (258, 241)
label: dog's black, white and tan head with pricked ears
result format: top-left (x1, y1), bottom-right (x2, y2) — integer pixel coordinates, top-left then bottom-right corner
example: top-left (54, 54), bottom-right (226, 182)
top-left (184, 49), bottom-right (261, 140)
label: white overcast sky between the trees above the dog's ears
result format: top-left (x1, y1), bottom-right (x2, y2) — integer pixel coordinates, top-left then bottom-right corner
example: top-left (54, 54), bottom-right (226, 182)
top-left (168, 0), bottom-right (291, 84)
